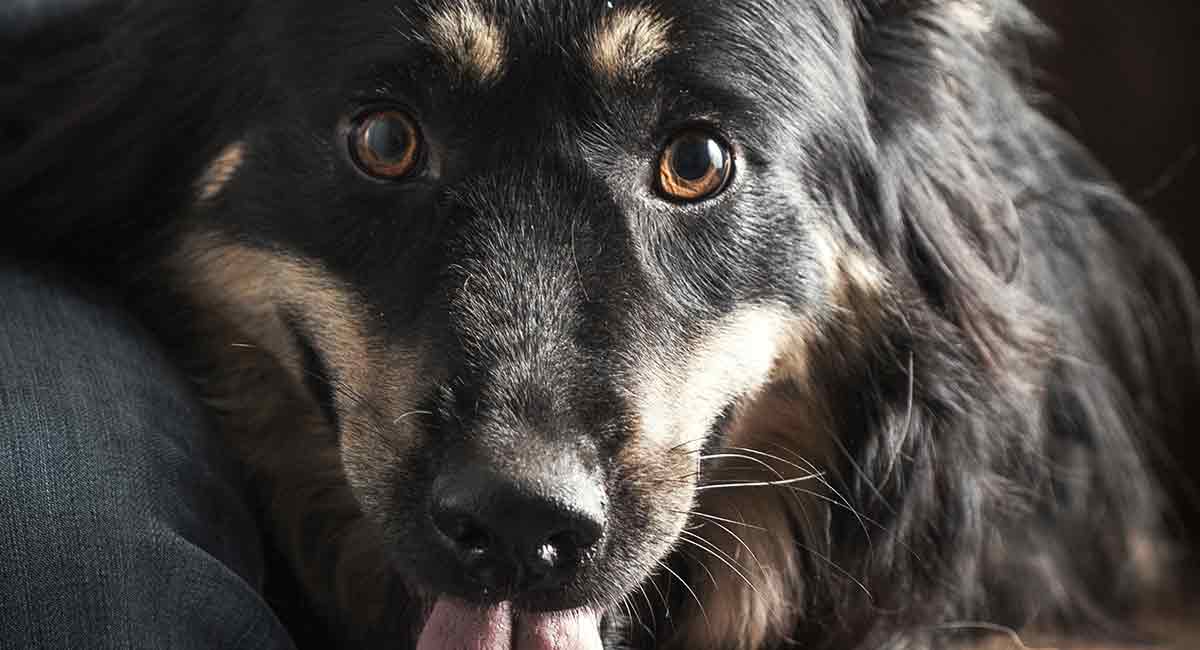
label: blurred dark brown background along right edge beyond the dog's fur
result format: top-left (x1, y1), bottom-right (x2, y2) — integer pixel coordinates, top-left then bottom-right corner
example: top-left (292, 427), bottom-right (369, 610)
top-left (1031, 0), bottom-right (1200, 537)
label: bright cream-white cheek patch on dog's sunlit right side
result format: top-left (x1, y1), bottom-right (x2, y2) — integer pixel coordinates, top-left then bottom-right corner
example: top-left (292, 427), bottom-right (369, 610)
top-left (600, 308), bottom-right (796, 597)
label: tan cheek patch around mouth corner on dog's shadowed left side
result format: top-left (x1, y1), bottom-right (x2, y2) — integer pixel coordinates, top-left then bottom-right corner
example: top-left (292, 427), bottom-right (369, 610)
top-left (170, 231), bottom-right (437, 516)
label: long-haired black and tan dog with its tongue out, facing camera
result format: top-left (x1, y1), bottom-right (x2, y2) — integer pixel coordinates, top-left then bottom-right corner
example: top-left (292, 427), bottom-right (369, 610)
top-left (0, 0), bottom-right (1198, 650)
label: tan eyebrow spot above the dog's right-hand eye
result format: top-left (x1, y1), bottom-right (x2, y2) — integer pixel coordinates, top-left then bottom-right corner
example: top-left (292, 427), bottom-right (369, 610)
top-left (590, 6), bottom-right (671, 83)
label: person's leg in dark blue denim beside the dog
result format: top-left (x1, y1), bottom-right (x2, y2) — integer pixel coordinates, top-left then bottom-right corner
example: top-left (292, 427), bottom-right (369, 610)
top-left (0, 264), bottom-right (292, 650)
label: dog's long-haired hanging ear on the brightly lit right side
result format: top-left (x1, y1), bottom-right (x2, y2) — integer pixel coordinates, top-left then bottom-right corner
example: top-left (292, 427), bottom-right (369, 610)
top-left (859, 0), bottom-right (1042, 362)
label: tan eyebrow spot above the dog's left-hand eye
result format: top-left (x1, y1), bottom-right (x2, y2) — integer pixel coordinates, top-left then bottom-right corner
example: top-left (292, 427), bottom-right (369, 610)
top-left (428, 0), bottom-right (508, 84)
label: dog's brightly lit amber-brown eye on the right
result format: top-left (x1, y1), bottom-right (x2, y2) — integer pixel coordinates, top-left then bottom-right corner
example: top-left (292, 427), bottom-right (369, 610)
top-left (659, 131), bottom-right (733, 201)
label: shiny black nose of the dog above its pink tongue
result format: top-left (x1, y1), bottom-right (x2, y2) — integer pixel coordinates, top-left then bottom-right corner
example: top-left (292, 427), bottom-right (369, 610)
top-left (431, 469), bottom-right (605, 595)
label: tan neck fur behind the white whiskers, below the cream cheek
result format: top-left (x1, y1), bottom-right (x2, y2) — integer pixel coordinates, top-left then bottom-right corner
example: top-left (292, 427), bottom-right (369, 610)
top-left (672, 320), bottom-right (835, 650)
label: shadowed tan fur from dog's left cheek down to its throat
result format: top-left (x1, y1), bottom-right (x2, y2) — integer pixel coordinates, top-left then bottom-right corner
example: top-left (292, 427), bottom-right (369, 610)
top-left (166, 233), bottom-right (430, 634)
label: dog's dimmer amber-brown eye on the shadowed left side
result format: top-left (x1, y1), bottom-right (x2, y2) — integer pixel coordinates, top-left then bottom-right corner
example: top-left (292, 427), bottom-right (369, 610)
top-left (350, 110), bottom-right (421, 179)
